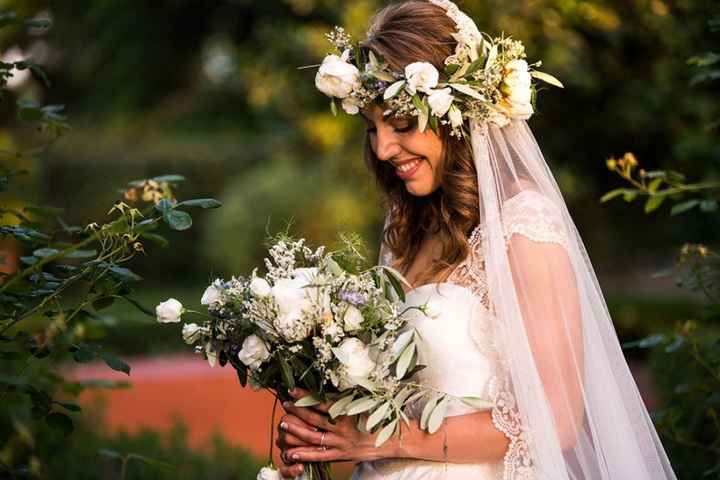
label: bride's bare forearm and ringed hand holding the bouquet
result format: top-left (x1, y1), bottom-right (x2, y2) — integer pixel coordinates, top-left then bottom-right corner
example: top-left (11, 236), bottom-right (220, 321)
top-left (278, 394), bottom-right (509, 476)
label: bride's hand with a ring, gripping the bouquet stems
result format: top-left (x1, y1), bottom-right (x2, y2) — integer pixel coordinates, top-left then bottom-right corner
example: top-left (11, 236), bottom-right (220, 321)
top-left (278, 389), bottom-right (394, 475)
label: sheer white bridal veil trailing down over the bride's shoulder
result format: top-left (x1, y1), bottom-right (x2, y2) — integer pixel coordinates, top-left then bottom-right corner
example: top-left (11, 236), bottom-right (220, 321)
top-left (470, 120), bottom-right (675, 480)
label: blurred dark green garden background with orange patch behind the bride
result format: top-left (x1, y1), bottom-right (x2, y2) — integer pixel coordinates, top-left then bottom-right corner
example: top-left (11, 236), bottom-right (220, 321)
top-left (0, 0), bottom-right (720, 479)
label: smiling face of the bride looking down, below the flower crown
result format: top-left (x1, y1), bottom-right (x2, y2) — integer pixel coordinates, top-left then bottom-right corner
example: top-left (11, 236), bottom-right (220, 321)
top-left (361, 103), bottom-right (443, 197)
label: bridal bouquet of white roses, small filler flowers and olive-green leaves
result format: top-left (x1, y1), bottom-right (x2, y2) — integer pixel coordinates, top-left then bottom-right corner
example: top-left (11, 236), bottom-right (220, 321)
top-left (156, 232), bottom-right (484, 478)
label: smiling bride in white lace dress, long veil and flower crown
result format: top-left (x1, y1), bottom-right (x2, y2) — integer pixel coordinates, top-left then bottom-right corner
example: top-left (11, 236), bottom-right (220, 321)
top-left (277, 0), bottom-right (675, 480)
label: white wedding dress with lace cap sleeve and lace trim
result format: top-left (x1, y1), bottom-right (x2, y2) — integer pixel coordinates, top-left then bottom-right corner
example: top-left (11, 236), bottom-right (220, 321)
top-left (352, 190), bottom-right (567, 480)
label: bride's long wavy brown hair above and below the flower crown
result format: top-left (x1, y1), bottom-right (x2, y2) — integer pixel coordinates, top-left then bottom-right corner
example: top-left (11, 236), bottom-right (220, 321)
top-left (362, 0), bottom-right (479, 284)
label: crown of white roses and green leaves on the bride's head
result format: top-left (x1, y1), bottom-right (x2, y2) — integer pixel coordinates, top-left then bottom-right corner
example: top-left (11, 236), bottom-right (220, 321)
top-left (315, 0), bottom-right (563, 137)
